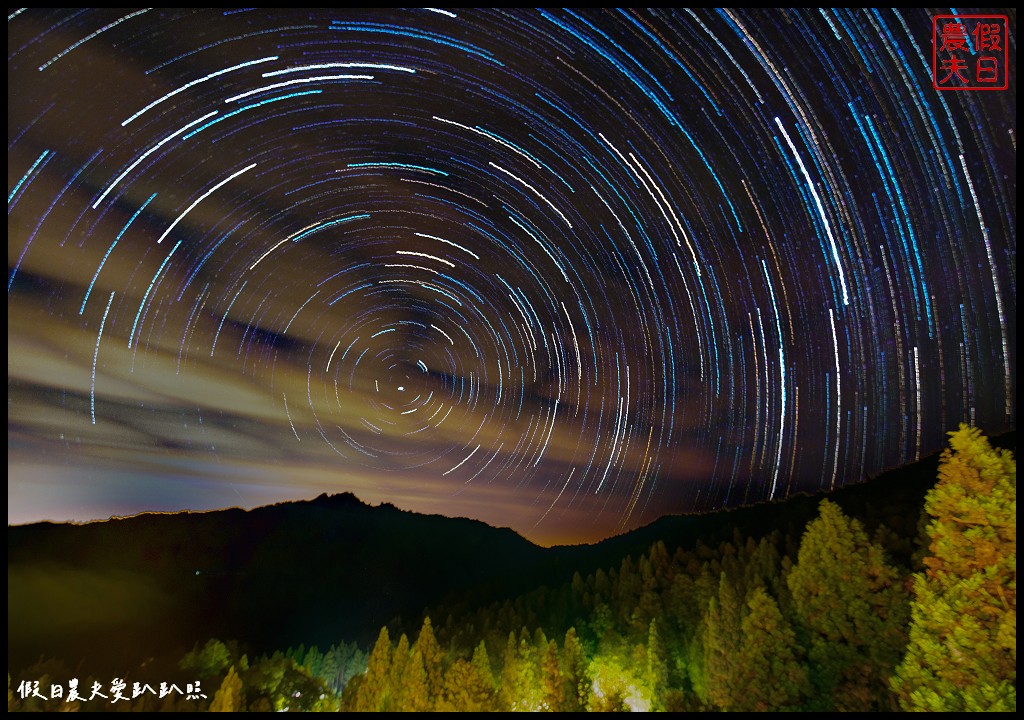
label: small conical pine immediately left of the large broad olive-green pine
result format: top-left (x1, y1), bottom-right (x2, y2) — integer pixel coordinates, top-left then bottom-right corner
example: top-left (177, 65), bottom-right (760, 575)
top-left (732, 588), bottom-right (810, 712)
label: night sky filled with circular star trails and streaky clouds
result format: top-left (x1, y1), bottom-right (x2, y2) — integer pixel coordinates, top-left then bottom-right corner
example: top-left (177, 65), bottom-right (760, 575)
top-left (7, 8), bottom-right (1017, 544)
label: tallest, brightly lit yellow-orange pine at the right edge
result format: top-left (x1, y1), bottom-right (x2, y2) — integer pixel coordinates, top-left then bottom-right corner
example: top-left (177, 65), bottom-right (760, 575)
top-left (892, 425), bottom-right (1017, 712)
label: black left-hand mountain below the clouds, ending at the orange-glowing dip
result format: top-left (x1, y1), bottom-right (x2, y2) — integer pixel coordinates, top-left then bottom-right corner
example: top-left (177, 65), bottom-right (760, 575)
top-left (7, 494), bottom-right (551, 667)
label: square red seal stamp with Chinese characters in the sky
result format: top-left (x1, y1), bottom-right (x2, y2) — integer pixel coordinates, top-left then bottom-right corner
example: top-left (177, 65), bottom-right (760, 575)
top-left (932, 15), bottom-right (1010, 90)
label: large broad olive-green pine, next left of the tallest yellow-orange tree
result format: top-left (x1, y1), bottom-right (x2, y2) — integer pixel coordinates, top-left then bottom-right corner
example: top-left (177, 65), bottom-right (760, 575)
top-left (786, 500), bottom-right (909, 711)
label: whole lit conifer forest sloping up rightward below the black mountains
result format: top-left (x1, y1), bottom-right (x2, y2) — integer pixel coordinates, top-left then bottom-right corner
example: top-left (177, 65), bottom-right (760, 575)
top-left (8, 426), bottom-right (1016, 712)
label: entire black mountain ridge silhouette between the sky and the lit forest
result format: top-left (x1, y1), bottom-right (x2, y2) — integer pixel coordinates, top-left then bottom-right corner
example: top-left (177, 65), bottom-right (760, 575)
top-left (7, 431), bottom-right (1016, 669)
